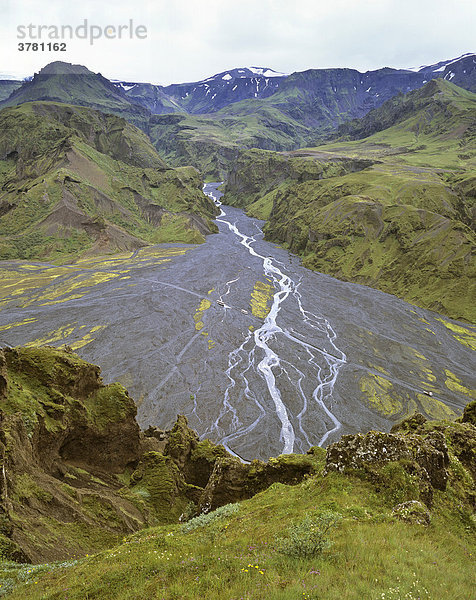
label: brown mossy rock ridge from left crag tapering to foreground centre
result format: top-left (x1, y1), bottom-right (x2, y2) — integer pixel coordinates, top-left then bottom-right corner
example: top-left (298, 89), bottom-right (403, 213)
top-left (0, 347), bottom-right (317, 564)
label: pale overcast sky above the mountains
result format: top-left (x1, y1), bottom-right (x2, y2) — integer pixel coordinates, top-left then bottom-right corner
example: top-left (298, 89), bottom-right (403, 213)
top-left (0, 0), bottom-right (476, 84)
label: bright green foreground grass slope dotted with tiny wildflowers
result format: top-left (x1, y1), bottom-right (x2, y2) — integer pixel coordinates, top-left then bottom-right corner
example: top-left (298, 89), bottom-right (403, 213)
top-left (0, 423), bottom-right (476, 600)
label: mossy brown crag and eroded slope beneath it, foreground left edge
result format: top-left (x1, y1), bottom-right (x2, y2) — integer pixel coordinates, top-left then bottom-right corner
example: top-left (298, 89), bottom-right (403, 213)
top-left (0, 348), bottom-right (150, 562)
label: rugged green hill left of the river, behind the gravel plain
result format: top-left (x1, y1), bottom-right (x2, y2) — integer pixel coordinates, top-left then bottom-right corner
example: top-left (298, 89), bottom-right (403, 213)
top-left (0, 102), bottom-right (216, 261)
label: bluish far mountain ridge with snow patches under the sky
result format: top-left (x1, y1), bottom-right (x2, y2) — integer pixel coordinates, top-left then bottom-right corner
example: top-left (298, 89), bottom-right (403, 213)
top-left (116, 54), bottom-right (476, 121)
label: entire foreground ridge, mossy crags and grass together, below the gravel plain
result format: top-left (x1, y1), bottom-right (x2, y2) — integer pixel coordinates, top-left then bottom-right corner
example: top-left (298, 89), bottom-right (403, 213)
top-left (0, 348), bottom-right (476, 600)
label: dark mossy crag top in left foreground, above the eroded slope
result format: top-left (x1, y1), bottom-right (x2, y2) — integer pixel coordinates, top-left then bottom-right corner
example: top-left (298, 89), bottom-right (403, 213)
top-left (4, 348), bottom-right (140, 474)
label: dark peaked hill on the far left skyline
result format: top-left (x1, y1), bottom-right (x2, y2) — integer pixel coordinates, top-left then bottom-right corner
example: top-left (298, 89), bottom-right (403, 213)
top-left (0, 61), bottom-right (150, 129)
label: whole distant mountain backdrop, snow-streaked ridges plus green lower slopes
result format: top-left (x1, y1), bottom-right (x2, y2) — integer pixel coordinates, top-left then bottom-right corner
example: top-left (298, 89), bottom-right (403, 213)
top-left (0, 54), bottom-right (476, 177)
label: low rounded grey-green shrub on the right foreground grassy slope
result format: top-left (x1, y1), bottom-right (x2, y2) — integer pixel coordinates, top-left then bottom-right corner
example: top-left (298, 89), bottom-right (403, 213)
top-left (276, 510), bottom-right (342, 557)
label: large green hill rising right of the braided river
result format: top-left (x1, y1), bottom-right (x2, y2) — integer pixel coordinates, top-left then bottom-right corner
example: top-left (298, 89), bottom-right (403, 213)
top-left (223, 81), bottom-right (476, 322)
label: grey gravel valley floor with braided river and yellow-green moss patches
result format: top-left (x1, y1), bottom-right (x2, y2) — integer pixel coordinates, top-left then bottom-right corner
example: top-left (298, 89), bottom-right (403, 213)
top-left (0, 192), bottom-right (476, 460)
